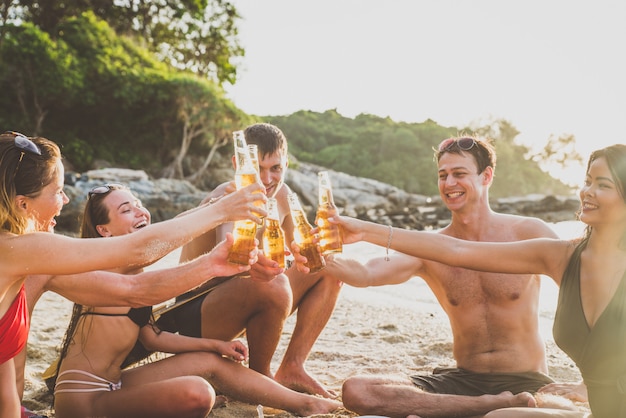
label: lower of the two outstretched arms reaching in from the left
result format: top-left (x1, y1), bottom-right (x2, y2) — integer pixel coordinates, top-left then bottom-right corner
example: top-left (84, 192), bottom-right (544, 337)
top-left (45, 234), bottom-right (258, 307)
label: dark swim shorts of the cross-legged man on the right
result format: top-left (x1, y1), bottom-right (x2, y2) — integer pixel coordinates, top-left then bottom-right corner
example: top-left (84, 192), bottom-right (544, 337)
top-left (410, 367), bottom-right (554, 396)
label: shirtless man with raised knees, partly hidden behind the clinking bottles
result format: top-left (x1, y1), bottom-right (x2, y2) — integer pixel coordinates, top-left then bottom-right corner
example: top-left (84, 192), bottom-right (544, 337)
top-left (162, 123), bottom-right (341, 397)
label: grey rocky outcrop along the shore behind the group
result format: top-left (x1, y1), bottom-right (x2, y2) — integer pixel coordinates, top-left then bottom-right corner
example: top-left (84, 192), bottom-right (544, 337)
top-left (57, 163), bottom-right (579, 233)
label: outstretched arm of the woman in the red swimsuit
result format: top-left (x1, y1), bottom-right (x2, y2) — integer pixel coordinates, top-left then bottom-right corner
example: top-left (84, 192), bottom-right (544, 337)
top-left (0, 184), bottom-right (266, 277)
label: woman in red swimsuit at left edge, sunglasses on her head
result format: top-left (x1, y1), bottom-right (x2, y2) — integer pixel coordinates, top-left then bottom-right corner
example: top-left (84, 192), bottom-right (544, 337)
top-left (0, 132), bottom-right (265, 418)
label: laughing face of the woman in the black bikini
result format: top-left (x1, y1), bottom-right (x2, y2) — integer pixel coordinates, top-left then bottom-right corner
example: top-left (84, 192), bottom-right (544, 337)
top-left (96, 189), bottom-right (151, 237)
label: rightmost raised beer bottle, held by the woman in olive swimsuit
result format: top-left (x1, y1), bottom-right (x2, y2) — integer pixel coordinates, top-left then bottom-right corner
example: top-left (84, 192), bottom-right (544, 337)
top-left (315, 171), bottom-right (343, 254)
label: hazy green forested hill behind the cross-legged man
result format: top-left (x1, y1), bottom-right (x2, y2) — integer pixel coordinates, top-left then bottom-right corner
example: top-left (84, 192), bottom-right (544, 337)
top-left (265, 110), bottom-right (570, 197)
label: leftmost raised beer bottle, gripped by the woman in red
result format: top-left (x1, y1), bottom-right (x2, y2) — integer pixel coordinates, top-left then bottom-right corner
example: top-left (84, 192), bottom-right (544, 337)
top-left (228, 131), bottom-right (258, 265)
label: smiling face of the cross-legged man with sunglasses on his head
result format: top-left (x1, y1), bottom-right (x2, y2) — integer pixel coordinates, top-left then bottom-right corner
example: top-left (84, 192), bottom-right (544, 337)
top-left (438, 152), bottom-right (493, 211)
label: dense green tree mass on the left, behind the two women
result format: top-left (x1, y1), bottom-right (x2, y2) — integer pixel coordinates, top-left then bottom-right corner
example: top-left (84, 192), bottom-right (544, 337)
top-left (0, 12), bottom-right (248, 173)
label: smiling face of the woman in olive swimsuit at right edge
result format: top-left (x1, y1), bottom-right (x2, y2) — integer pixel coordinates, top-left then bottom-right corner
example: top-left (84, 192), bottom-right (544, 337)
top-left (580, 157), bottom-right (626, 228)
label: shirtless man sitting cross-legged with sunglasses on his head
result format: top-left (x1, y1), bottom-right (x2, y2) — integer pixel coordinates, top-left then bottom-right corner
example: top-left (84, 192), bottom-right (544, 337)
top-left (327, 137), bottom-right (580, 417)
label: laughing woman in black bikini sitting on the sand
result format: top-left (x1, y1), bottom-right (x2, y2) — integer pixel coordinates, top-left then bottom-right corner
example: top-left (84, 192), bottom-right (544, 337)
top-left (54, 185), bottom-right (340, 418)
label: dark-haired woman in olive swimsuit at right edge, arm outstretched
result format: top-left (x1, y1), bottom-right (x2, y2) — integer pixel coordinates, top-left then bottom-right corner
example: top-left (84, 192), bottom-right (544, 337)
top-left (336, 144), bottom-right (626, 418)
